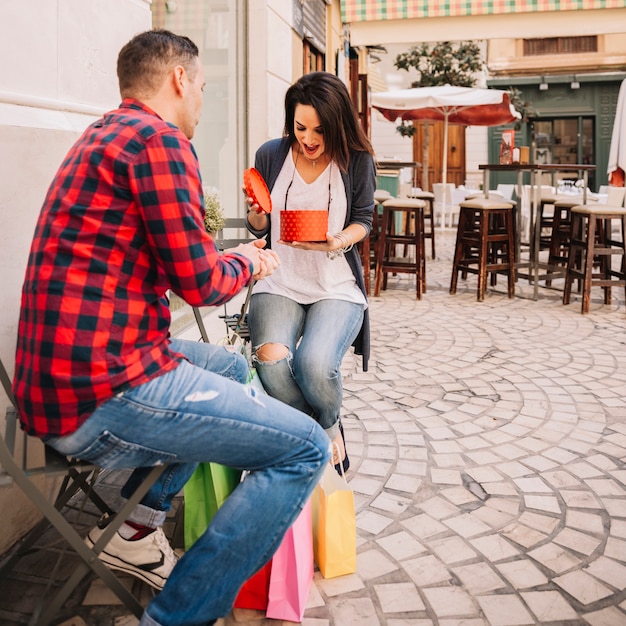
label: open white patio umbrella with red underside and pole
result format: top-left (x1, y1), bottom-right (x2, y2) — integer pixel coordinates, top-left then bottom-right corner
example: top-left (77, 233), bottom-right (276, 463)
top-left (372, 85), bottom-right (521, 223)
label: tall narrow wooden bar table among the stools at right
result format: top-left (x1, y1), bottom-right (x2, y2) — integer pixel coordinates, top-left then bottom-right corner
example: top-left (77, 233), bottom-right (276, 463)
top-left (478, 163), bottom-right (596, 300)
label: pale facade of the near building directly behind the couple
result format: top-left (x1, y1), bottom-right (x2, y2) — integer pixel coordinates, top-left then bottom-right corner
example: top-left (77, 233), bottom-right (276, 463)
top-left (0, 0), bottom-right (347, 554)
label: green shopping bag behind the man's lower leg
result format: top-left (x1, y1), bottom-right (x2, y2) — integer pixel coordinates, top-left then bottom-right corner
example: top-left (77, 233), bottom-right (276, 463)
top-left (184, 463), bottom-right (241, 550)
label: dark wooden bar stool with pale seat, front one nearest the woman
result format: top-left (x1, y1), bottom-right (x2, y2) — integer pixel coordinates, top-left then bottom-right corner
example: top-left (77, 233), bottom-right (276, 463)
top-left (374, 198), bottom-right (426, 300)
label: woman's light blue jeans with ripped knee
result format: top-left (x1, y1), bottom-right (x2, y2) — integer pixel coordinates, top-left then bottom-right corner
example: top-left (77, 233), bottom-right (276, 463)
top-left (248, 293), bottom-right (363, 439)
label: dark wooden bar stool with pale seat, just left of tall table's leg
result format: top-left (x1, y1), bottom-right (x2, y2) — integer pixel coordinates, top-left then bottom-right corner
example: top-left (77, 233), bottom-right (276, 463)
top-left (450, 197), bottom-right (515, 302)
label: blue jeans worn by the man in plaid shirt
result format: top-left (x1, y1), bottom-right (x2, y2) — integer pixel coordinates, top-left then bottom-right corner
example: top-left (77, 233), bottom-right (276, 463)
top-left (48, 340), bottom-right (330, 626)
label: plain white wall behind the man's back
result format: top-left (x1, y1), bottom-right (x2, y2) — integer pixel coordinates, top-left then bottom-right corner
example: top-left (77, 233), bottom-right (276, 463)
top-left (0, 0), bottom-right (152, 553)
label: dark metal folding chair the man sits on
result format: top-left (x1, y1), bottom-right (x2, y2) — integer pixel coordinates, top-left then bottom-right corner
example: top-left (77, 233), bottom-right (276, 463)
top-left (0, 361), bottom-right (167, 626)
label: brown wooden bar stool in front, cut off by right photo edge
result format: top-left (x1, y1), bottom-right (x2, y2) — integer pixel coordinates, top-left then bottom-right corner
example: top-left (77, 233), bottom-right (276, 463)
top-left (563, 204), bottom-right (626, 313)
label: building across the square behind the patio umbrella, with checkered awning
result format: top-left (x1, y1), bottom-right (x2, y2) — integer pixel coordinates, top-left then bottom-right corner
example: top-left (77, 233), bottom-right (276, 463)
top-left (342, 0), bottom-right (626, 189)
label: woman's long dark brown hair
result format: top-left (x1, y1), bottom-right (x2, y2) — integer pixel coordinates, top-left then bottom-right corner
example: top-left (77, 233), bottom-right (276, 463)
top-left (284, 72), bottom-right (374, 172)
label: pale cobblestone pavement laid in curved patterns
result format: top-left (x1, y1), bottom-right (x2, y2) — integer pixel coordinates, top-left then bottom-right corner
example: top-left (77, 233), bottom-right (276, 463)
top-left (0, 233), bottom-right (626, 626)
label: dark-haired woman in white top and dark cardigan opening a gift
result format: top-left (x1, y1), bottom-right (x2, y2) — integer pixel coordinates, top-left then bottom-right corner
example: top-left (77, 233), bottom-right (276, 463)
top-left (248, 72), bottom-right (376, 471)
